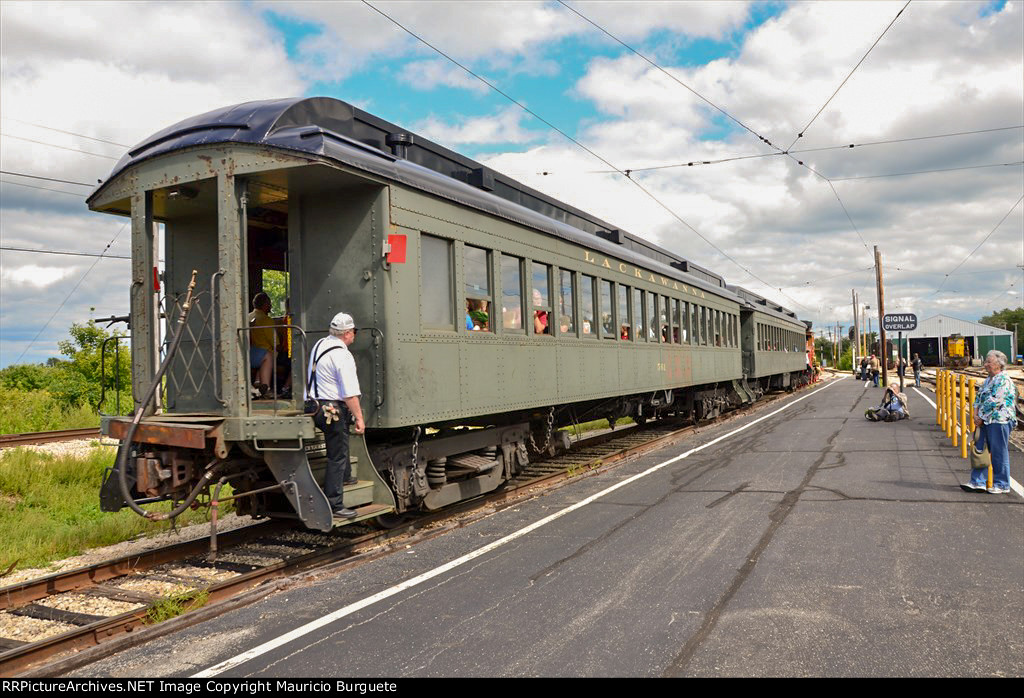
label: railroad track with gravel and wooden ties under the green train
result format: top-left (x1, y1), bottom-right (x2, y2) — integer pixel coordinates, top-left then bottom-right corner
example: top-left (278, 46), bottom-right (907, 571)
top-left (0, 380), bottom-right (811, 677)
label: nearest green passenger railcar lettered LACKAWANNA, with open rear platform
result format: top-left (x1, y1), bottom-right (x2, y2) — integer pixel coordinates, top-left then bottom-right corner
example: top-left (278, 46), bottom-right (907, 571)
top-left (89, 98), bottom-right (799, 530)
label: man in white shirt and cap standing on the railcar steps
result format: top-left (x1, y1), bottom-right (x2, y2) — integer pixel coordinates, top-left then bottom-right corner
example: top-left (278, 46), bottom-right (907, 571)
top-left (305, 312), bottom-right (366, 519)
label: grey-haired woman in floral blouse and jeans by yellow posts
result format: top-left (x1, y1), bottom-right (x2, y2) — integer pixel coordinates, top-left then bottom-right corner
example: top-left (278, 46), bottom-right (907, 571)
top-left (967, 350), bottom-right (1017, 494)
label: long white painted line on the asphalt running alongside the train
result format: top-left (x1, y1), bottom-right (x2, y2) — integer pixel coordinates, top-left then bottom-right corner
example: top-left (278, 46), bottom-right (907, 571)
top-left (191, 376), bottom-right (847, 679)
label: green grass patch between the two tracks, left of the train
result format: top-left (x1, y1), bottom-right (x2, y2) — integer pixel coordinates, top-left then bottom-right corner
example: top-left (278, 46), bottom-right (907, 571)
top-left (0, 447), bottom-right (232, 569)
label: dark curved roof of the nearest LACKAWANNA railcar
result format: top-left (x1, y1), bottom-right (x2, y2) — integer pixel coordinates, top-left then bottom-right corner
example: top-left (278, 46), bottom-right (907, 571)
top-left (88, 97), bottom-right (741, 301)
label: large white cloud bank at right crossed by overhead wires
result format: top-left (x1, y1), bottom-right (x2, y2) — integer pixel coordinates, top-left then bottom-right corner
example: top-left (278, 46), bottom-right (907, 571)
top-left (481, 2), bottom-right (1024, 319)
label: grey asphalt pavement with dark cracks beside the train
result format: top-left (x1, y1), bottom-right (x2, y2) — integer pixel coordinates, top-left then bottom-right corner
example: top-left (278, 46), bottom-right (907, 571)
top-left (75, 378), bottom-right (1024, 678)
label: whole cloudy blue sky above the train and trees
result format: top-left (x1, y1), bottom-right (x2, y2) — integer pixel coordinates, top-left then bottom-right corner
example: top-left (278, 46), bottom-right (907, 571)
top-left (0, 0), bottom-right (1024, 367)
